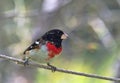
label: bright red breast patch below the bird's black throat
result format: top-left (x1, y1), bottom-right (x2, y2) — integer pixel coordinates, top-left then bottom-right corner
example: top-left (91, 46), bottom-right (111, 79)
top-left (46, 42), bottom-right (62, 59)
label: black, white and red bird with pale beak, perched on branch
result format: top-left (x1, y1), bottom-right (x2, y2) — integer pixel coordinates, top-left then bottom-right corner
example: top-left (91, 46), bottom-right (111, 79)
top-left (23, 29), bottom-right (68, 72)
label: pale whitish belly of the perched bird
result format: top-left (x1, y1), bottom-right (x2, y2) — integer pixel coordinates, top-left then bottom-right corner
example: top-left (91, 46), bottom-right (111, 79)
top-left (30, 45), bottom-right (48, 63)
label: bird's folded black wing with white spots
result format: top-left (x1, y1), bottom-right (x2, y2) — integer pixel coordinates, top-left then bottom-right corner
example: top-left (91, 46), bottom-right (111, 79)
top-left (23, 38), bottom-right (46, 54)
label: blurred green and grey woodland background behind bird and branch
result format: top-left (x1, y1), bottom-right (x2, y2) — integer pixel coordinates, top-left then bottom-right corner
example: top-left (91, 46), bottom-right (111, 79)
top-left (0, 0), bottom-right (120, 83)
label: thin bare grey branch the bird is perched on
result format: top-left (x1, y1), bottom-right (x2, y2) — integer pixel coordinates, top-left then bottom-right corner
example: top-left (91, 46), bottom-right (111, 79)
top-left (0, 54), bottom-right (120, 82)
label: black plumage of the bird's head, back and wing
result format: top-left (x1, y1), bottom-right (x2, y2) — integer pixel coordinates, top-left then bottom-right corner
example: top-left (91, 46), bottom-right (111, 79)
top-left (23, 29), bottom-right (64, 54)
